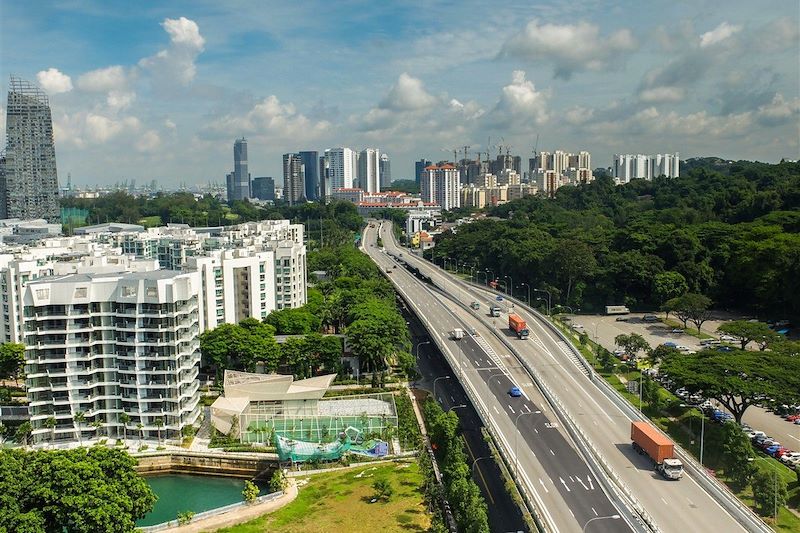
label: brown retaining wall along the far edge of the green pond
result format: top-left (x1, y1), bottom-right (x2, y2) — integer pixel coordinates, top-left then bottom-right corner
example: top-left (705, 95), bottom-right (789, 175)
top-left (136, 452), bottom-right (278, 479)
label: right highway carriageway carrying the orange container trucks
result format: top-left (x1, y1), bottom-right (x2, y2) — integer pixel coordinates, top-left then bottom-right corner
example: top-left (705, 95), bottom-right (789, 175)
top-left (381, 223), bottom-right (763, 533)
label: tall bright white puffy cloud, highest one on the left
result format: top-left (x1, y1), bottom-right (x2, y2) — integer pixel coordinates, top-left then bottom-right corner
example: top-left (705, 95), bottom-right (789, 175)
top-left (139, 17), bottom-right (205, 85)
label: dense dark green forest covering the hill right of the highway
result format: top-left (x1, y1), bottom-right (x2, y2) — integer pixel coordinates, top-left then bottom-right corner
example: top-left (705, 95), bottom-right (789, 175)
top-left (434, 161), bottom-right (800, 318)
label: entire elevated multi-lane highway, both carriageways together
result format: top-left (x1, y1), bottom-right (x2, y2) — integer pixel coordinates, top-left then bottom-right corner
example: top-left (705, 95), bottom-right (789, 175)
top-left (364, 223), bottom-right (761, 533)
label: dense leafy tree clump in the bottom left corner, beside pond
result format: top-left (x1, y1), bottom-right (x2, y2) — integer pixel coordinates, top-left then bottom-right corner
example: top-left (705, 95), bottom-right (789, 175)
top-left (0, 446), bottom-right (156, 533)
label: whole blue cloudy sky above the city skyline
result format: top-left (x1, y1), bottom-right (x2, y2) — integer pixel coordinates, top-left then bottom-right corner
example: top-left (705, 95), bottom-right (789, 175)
top-left (0, 0), bottom-right (800, 188)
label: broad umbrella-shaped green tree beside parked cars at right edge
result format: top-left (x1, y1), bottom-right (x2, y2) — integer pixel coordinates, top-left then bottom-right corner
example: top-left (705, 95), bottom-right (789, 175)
top-left (661, 350), bottom-right (800, 423)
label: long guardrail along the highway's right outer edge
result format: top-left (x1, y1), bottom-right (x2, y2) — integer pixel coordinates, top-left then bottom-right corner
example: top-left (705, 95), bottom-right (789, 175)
top-left (463, 281), bottom-right (773, 533)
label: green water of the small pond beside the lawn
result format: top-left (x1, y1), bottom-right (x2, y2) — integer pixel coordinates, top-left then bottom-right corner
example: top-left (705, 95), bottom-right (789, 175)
top-left (136, 474), bottom-right (253, 526)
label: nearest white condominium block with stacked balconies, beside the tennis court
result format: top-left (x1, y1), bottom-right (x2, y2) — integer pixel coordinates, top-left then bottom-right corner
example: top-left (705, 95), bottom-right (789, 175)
top-left (24, 270), bottom-right (203, 444)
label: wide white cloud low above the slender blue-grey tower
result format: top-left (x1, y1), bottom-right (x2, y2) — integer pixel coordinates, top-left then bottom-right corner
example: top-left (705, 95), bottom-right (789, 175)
top-left (206, 95), bottom-right (330, 140)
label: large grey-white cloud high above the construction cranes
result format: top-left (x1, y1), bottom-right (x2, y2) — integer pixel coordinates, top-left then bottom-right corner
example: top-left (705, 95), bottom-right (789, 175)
top-left (500, 19), bottom-right (638, 79)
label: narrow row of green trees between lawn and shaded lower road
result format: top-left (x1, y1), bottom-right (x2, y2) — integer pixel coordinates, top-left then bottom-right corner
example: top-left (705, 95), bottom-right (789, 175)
top-left (423, 398), bottom-right (489, 533)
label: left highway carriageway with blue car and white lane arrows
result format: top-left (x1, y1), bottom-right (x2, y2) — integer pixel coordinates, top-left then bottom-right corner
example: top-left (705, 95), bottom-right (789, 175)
top-left (363, 221), bottom-right (642, 532)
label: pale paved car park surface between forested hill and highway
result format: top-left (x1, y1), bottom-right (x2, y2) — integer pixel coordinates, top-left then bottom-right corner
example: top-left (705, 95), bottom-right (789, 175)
top-left (570, 313), bottom-right (800, 458)
